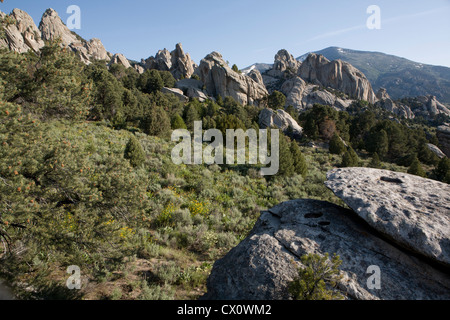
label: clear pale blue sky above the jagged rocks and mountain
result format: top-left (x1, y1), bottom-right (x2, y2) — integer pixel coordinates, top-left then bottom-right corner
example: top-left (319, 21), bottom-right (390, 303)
top-left (0, 0), bottom-right (450, 68)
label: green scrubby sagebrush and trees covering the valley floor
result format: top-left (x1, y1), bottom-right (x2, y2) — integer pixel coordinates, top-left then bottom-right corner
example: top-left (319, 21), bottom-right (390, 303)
top-left (0, 42), bottom-right (450, 299)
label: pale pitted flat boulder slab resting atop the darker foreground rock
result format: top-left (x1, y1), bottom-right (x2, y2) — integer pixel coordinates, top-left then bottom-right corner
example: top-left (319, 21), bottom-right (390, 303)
top-left (325, 168), bottom-right (450, 267)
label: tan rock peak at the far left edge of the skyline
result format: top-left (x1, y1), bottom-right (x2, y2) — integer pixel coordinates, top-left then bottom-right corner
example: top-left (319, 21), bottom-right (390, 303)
top-left (0, 9), bottom-right (44, 53)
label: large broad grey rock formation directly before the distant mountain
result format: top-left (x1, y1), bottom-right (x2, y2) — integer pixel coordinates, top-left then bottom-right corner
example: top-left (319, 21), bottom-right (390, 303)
top-left (262, 50), bottom-right (370, 111)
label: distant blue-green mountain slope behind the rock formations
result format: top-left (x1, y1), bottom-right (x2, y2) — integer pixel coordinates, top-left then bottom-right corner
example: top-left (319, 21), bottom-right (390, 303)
top-left (297, 47), bottom-right (450, 104)
